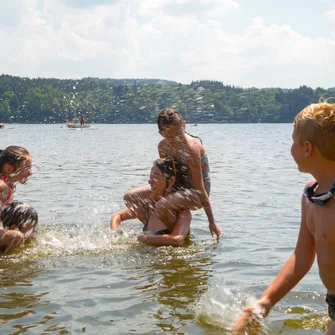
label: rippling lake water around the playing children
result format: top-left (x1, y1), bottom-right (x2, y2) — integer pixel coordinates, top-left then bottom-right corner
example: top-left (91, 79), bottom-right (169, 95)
top-left (0, 124), bottom-right (327, 335)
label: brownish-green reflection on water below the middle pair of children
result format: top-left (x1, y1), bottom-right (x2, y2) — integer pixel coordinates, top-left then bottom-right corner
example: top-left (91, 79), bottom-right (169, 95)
top-left (136, 248), bottom-right (218, 333)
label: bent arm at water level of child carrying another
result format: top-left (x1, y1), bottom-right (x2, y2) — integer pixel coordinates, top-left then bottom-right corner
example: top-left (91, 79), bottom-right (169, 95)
top-left (137, 209), bottom-right (192, 247)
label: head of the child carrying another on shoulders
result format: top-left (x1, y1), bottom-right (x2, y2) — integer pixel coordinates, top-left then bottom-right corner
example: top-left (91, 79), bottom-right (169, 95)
top-left (149, 157), bottom-right (187, 198)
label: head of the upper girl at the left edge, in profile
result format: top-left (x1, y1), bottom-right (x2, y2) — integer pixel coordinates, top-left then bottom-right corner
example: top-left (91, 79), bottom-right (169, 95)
top-left (0, 146), bottom-right (32, 184)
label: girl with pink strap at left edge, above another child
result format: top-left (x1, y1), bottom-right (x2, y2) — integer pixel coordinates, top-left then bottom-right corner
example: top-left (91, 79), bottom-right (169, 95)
top-left (0, 146), bottom-right (32, 207)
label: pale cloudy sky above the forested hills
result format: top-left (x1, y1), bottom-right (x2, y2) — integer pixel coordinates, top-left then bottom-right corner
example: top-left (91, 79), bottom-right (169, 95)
top-left (0, 0), bottom-right (335, 88)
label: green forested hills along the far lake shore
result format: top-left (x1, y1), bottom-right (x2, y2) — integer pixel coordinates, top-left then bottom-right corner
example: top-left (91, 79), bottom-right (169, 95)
top-left (0, 74), bottom-right (335, 123)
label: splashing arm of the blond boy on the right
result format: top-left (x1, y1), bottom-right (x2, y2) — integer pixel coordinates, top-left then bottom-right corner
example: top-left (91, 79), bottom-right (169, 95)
top-left (233, 197), bottom-right (316, 334)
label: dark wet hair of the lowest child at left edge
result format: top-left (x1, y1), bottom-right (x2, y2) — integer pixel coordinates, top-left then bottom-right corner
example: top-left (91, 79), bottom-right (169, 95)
top-left (1, 201), bottom-right (38, 230)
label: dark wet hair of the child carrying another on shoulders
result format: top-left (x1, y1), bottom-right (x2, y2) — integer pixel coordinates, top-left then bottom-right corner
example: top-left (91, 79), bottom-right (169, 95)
top-left (154, 157), bottom-right (188, 191)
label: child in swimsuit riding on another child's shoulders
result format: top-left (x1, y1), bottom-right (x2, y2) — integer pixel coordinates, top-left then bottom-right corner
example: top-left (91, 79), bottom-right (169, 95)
top-left (124, 108), bottom-right (221, 237)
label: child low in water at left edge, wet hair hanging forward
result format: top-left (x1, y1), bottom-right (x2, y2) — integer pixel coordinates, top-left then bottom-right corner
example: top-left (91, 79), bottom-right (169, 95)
top-left (0, 201), bottom-right (38, 254)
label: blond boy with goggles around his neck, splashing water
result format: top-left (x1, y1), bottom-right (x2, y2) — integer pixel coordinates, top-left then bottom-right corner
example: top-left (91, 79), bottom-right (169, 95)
top-left (233, 103), bottom-right (335, 335)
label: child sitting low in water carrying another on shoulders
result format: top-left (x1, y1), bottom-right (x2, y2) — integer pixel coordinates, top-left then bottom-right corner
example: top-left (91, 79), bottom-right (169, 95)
top-left (111, 158), bottom-right (191, 247)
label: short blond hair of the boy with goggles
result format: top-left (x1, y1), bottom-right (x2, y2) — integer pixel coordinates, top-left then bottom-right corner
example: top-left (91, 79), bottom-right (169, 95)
top-left (293, 102), bottom-right (335, 161)
